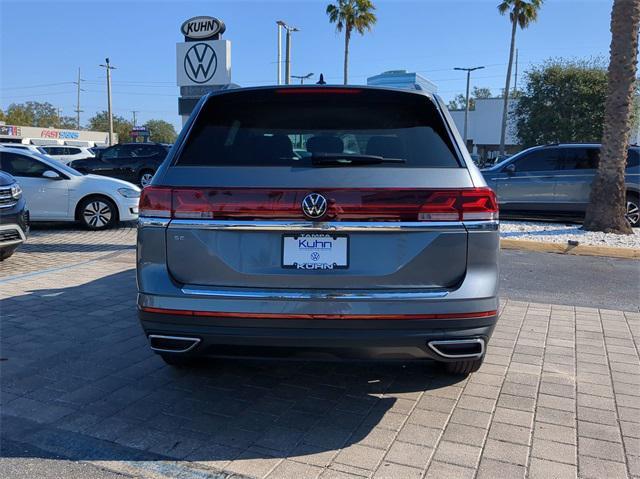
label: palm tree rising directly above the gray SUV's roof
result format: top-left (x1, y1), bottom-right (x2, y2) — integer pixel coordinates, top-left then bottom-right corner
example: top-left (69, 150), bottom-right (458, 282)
top-left (327, 0), bottom-right (377, 85)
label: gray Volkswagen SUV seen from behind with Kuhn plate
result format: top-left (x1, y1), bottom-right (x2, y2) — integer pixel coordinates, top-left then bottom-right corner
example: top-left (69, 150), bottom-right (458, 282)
top-left (137, 86), bottom-right (498, 374)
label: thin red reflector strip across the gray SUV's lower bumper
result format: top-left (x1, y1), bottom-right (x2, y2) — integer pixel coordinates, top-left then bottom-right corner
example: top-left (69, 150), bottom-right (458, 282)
top-left (140, 306), bottom-right (498, 320)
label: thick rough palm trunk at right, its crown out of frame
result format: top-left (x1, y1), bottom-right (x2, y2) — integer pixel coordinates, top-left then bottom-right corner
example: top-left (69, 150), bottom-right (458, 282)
top-left (584, 0), bottom-right (640, 234)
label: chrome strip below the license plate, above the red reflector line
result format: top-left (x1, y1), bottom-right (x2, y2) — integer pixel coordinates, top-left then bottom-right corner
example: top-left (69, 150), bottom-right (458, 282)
top-left (182, 288), bottom-right (449, 301)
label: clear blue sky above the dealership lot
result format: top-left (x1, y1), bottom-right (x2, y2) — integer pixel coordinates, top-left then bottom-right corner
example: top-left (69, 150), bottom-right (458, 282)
top-left (0, 0), bottom-right (612, 131)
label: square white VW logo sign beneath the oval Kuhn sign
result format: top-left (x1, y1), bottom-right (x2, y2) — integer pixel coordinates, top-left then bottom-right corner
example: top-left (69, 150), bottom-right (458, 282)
top-left (176, 40), bottom-right (231, 86)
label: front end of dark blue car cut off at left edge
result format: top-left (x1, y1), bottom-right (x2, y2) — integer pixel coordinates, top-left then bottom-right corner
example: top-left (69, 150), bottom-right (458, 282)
top-left (0, 171), bottom-right (29, 261)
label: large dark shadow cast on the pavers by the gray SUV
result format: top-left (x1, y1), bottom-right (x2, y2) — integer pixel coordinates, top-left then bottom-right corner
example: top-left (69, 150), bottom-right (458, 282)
top-left (0, 270), bottom-right (468, 465)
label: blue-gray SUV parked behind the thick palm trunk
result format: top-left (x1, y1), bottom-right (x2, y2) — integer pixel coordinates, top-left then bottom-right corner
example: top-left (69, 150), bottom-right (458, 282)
top-left (482, 144), bottom-right (640, 226)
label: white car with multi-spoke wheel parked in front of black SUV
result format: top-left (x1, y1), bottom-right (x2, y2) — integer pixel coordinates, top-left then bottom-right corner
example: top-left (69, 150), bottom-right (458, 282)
top-left (0, 148), bottom-right (140, 230)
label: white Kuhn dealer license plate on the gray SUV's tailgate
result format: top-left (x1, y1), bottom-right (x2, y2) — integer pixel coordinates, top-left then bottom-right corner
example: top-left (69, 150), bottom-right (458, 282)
top-left (282, 234), bottom-right (349, 270)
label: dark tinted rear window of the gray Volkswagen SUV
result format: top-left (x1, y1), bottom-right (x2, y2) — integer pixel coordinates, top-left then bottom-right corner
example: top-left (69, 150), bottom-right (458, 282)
top-left (175, 89), bottom-right (460, 168)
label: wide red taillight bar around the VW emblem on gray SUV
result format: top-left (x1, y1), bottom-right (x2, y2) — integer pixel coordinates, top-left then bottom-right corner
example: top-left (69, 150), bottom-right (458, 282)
top-left (140, 186), bottom-right (498, 221)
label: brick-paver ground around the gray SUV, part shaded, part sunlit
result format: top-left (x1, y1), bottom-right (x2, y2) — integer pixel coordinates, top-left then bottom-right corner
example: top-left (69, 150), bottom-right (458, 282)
top-left (0, 227), bottom-right (640, 479)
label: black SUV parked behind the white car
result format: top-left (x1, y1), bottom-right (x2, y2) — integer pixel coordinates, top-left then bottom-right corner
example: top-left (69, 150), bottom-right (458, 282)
top-left (70, 143), bottom-right (169, 187)
